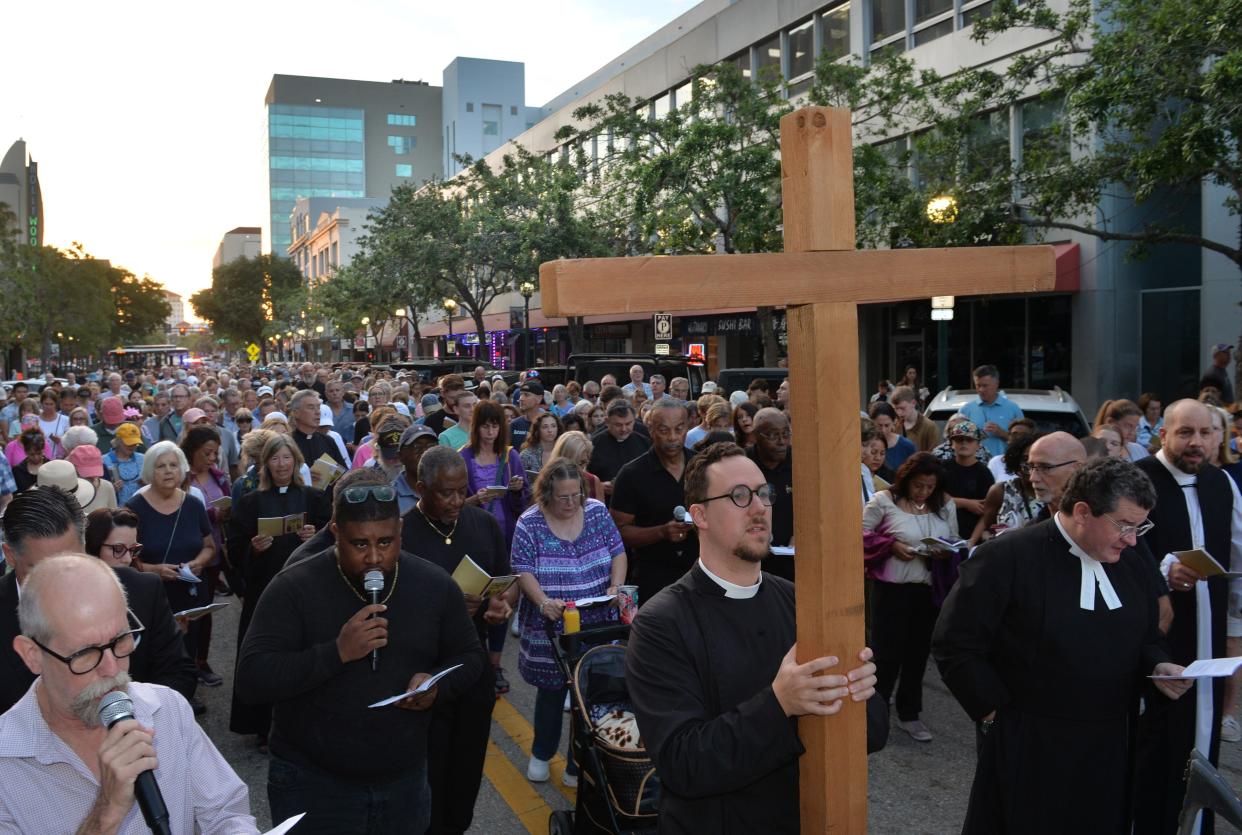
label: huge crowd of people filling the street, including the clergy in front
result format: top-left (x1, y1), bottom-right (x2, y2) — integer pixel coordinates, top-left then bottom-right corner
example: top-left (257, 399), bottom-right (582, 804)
top-left (0, 347), bottom-right (1242, 833)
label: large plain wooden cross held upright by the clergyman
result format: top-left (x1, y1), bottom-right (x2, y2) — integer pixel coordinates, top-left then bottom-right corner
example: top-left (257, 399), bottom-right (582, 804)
top-left (539, 107), bottom-right (1056, 835)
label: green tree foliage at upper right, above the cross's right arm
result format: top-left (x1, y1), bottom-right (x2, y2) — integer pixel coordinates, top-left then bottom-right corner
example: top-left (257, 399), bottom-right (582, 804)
top-left (812, 0), bottom-right (1242, 385)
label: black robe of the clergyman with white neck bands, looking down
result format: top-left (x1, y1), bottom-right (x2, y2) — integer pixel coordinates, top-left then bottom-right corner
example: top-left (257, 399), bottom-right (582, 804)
top-left (932, 521), bottom-right (1167, 835)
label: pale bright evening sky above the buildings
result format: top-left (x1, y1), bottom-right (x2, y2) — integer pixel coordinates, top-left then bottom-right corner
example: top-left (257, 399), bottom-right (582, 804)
top-left (0, 0), bottom-right (697, 314)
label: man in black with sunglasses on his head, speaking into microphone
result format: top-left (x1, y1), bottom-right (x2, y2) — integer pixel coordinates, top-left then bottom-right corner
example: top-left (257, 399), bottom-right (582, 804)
top-left (237, 472), bottom-right (484, 835)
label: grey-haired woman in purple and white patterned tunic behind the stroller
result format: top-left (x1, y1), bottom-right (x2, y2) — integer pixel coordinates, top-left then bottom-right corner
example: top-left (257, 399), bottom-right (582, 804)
top-left (512, 459), bottom-right (626, 785)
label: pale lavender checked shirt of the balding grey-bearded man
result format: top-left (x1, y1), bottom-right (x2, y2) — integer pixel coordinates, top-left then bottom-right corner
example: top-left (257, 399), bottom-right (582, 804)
top-left (0, 680), bottom-right (258, 835)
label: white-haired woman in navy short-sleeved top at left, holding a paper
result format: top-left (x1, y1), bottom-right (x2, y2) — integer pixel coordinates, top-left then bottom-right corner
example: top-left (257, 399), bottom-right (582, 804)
top-left (125, 441), bottom-right (215, 659)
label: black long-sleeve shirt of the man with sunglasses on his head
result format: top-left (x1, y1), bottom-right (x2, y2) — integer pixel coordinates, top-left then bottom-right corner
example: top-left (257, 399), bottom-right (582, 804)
top-left (237, 549), bottom-right (486, 780)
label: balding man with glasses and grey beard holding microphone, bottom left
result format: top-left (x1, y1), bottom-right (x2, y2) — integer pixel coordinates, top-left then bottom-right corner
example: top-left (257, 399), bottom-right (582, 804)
top-left (0, 555), bottom-right (258, 835)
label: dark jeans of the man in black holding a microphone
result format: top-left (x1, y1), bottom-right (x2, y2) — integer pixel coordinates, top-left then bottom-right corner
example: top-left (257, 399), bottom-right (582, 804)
top-left (267, 755), bottom-right (431, 835)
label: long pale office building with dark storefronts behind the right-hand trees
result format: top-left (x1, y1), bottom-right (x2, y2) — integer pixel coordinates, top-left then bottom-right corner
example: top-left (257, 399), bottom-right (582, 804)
top-left (409, 0), bottom-right (1242, 413)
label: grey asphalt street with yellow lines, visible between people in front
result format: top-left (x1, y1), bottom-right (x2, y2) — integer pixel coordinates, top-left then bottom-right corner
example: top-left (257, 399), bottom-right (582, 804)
top-left (199, 598), bottom-right (1242, 835)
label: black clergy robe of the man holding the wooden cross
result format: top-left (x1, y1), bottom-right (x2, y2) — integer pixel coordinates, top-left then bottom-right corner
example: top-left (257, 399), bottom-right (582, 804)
top-left (626, 564), bottom-right (887, 835)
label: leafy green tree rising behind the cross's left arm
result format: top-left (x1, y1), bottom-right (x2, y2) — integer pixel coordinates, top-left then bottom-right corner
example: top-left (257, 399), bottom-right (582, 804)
top-left (558, 63), bottom-right (791, 365)
